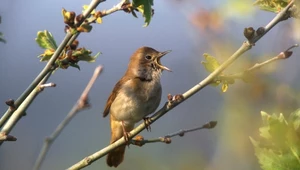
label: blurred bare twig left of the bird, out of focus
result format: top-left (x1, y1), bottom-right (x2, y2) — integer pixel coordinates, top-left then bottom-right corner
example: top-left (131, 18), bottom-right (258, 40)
top-left (33, 66), bottom-right (102, 170)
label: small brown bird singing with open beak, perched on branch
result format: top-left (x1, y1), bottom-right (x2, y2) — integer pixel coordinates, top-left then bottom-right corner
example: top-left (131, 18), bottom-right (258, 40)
top-left (103, 47), bottom-right (171, 167)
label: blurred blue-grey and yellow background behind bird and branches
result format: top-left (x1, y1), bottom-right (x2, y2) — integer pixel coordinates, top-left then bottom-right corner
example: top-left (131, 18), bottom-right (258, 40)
top-left (0, 0), bottom-right (300, 170)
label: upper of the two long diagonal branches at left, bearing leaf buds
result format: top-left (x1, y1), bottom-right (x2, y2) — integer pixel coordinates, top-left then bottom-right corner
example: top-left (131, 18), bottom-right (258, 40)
top-left (0, 0), bottom-right (105, 128)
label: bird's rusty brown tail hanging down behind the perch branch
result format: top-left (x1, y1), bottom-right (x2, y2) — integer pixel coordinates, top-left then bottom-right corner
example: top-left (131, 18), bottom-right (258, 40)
top-left (106, 116), bottom-right (134, 167)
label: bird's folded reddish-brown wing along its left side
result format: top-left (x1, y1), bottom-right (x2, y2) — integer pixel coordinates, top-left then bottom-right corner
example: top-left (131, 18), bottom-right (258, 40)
top-left (103, 77), bottom-right (129, 117)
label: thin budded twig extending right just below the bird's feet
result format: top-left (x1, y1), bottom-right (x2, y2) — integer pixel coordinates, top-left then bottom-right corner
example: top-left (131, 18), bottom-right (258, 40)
top-left (131, 121), bottom-right (217, 146)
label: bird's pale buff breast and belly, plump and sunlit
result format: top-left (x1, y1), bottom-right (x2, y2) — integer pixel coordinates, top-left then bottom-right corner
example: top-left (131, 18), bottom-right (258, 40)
top-left (110, 80), bottom-right (162, 124)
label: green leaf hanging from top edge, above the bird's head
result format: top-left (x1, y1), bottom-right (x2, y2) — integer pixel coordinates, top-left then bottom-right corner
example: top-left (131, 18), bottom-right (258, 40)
top-left (132, 0), bottom-right (153, 27)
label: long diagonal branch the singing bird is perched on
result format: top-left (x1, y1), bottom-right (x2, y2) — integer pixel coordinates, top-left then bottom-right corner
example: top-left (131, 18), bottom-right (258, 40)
top-left (68, 0), bottom-right (294, 169)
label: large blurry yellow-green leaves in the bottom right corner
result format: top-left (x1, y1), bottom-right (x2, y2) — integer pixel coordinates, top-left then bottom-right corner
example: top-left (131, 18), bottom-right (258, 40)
top-left (250, 109), bottom-right (300, 170)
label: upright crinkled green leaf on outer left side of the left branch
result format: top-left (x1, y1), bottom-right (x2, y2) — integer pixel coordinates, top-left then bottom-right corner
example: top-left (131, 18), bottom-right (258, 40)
top-left (35, 30), bottom-right (57, 50)
